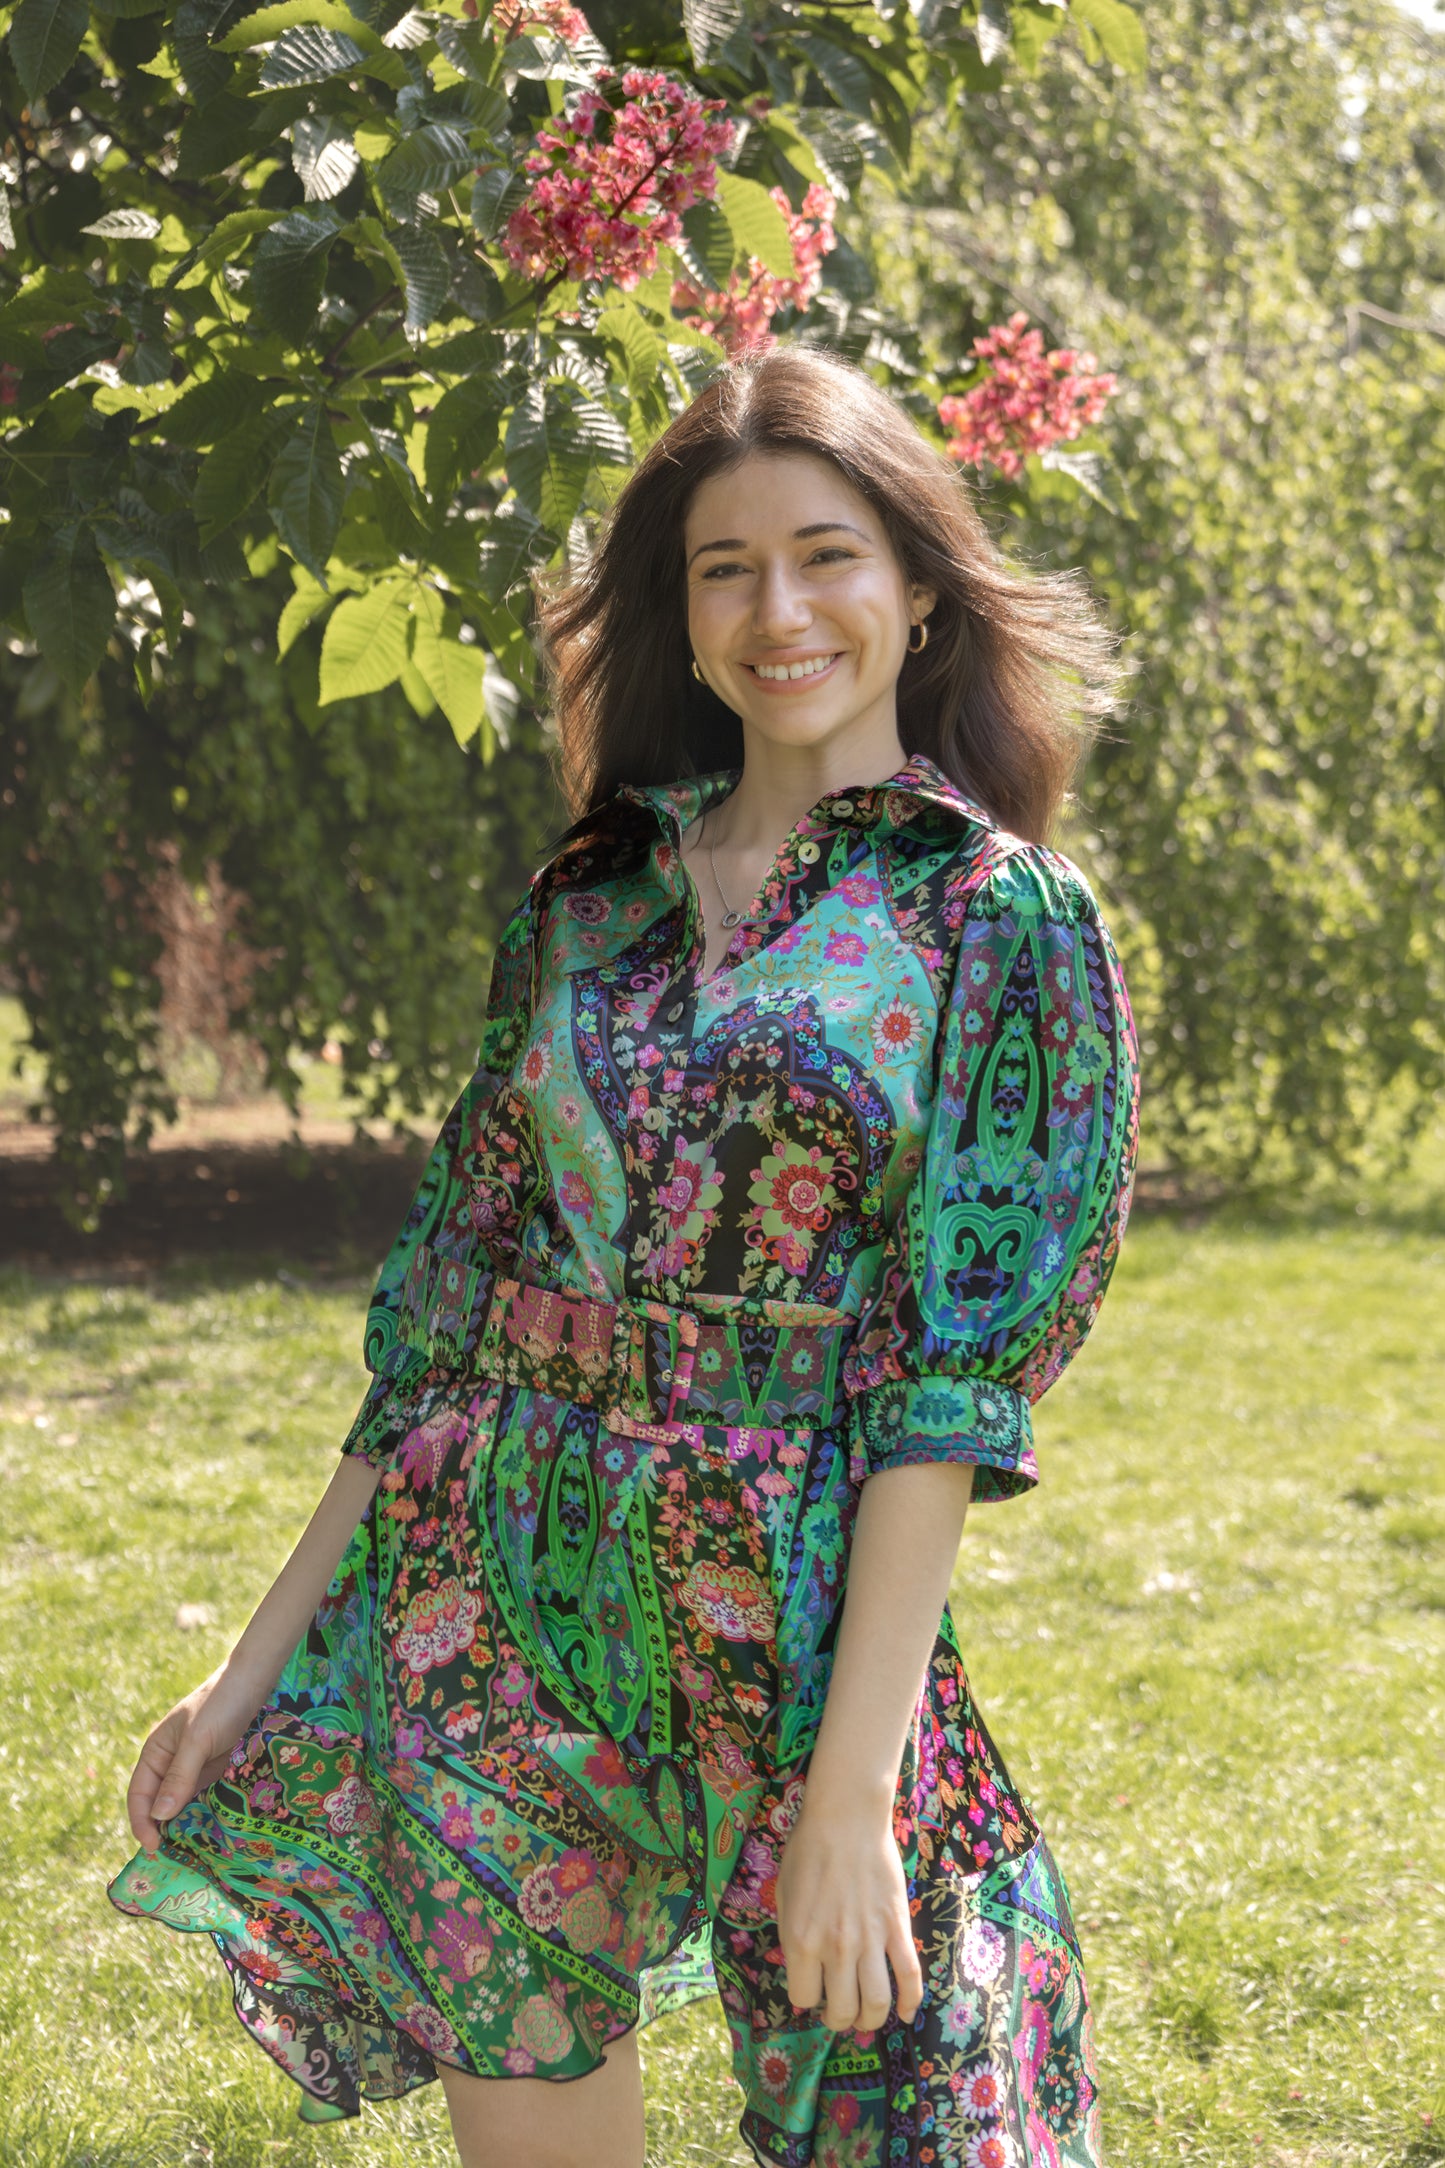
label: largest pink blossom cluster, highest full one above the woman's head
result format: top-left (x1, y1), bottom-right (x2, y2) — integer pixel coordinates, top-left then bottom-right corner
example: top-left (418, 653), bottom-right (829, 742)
top-left (503, 67), bottom-right (732, 288)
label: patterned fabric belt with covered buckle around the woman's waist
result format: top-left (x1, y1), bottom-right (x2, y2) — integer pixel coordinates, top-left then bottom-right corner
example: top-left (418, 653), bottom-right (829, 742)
top-left (396, 1242), bottom-right (854, 1444)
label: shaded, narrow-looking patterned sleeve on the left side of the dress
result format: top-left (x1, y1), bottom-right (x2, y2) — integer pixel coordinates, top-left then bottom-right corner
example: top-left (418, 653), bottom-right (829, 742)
top-left (340, 889), bottom-right (535, 1468)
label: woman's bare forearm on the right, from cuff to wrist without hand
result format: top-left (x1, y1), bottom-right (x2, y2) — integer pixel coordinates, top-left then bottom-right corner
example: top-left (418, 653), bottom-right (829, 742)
top-left (806, 1461), bottom-right (973, 1819)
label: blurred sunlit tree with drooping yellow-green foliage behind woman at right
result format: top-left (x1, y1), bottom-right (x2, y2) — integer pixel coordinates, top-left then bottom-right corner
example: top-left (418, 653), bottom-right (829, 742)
top-left (875, 0), bottom-right (1445, 1177)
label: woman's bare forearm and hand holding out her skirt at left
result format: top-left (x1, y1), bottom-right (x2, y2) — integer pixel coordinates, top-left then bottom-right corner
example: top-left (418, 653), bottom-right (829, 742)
top-left (126, 1455), bottom-right (381, 1851)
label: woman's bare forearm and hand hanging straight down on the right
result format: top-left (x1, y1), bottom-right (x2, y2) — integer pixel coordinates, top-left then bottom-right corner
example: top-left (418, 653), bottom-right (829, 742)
top-left (778, 1461), bottom-right (973, 2031)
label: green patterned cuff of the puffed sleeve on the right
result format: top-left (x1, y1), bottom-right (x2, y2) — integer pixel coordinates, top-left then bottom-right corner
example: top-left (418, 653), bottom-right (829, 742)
top-left (849, 1377), bottom-right (1038, 1502)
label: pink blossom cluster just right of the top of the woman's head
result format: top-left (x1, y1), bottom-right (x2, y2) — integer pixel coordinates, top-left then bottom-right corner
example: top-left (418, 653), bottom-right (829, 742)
top-left (938, 310), bottom-right (1118, 477)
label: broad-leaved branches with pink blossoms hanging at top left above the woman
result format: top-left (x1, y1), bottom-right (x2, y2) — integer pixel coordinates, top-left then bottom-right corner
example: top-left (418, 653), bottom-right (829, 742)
top-left (0, 0), bottom-right (1135, 711)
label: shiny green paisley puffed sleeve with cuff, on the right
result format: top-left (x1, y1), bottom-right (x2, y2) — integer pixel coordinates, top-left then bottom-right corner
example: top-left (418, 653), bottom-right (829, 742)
top-left (845, 837), bottom-right (1140, 1498)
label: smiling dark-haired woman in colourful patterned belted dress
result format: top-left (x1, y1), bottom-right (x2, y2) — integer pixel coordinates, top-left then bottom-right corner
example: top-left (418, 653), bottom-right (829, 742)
top-left (110, 349), bottom-right (1137, 2168)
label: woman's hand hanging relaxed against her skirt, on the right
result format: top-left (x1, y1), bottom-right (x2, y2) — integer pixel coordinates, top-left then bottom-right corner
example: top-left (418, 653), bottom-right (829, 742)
top-left (778, 1799), bottom-right (923, 2031)
